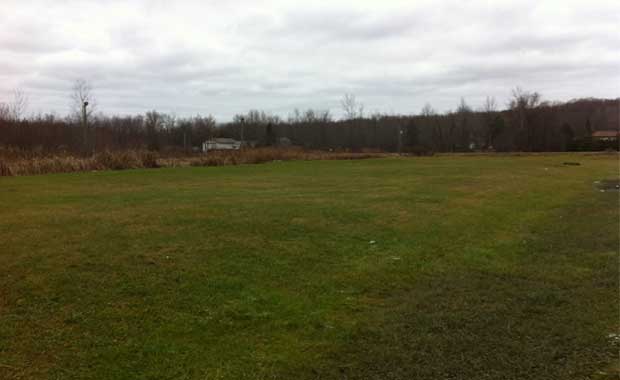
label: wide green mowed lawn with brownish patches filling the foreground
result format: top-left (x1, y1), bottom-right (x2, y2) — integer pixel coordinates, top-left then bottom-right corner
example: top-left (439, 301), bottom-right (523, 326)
top-left (0, 155), bottom-right (620, 379)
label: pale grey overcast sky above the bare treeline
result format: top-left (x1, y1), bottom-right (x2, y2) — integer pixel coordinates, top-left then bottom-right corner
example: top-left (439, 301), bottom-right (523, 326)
top-left (0, 0), bottom-right (620, 121)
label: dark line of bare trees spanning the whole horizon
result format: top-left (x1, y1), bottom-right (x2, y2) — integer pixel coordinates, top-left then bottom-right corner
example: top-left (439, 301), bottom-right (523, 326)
top-left (0, 90), bottom-right (620, 154)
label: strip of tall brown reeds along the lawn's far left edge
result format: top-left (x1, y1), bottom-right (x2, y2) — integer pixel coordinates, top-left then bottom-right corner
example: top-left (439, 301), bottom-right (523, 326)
top-left (0, 148), bottom-right (385, 176)
